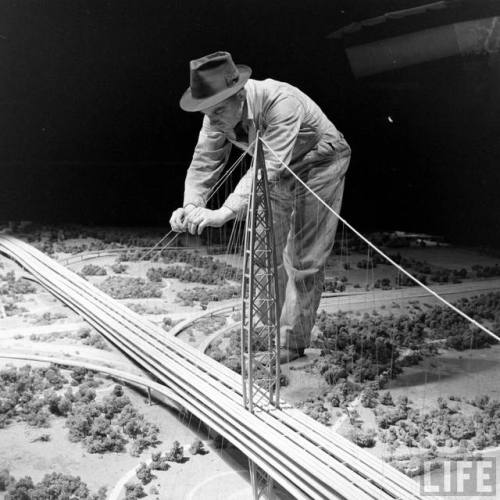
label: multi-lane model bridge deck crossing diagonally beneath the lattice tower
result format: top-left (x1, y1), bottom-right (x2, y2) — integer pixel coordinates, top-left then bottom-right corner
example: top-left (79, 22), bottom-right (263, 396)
top-left (0, 235), bottom-right (435, 500)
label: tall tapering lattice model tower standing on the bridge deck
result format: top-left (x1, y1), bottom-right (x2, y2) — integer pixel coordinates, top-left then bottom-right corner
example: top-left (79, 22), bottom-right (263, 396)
top-left (241, 133), bottom-right (280, 500)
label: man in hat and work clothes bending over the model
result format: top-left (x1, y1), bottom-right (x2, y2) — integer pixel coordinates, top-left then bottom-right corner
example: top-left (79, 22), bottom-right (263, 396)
top-left (170, 52), bottom-right (351, 362)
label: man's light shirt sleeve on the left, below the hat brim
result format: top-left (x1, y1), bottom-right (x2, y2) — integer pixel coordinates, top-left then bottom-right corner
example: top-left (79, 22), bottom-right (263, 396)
top-left (183, 116), bottom-right (231, 207)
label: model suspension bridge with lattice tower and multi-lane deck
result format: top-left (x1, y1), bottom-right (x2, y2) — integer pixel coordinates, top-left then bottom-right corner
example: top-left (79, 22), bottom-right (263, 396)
top-left (0, 135), bottom-right (494, 500)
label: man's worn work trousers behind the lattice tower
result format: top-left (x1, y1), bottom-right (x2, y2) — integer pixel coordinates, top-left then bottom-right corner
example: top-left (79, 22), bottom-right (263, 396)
top-left (269, 135), bottom-right (351, 349)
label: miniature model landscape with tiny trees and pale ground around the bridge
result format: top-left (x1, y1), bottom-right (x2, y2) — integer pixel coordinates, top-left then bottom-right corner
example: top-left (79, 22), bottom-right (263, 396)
top-left (0, 224), bottom-right (500, 500)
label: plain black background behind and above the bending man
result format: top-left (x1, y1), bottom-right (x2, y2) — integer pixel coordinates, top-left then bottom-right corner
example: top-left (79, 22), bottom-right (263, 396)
top-left (0, 0), bottom-right (500, 246)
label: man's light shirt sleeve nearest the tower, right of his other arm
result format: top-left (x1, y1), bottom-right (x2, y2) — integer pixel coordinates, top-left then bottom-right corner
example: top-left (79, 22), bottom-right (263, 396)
top-left (224, 95), bottom-right (304, 215)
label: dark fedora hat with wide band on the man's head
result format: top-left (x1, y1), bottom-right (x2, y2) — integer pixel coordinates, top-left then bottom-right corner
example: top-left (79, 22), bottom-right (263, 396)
top-left (179, 51), bottom-right (252, 111)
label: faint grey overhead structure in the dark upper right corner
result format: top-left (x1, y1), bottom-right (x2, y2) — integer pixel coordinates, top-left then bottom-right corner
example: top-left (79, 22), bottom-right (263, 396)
top-left (329, 0), bottom-right (500, 78)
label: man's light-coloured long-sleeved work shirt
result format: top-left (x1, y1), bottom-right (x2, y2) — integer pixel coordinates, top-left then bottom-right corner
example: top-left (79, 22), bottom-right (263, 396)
top-left (183, 79), bottom-right (345, 214)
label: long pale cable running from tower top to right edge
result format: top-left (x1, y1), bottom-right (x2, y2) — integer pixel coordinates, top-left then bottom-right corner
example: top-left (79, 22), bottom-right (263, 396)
top-left (259, 137), bottom-right (500, 342)
